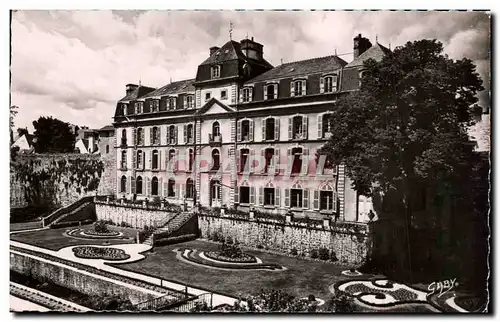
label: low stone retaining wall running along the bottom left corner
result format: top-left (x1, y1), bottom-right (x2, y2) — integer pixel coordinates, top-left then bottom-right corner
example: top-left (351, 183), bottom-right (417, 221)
top-left (10, 251), bottom-right (157, 304)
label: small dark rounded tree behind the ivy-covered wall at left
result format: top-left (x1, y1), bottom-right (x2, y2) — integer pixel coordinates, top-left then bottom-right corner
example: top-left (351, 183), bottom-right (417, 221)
top-left (33, 116), bottom-right (75, 153)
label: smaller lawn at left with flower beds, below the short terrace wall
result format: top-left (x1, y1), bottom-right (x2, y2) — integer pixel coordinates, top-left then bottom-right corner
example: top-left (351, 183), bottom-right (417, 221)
top-left (10, 225), bottom-right (137, 251)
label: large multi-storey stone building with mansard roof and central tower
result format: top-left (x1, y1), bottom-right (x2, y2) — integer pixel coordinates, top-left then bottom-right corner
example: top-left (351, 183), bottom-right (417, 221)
top-left (114, 35), bottom-right (389, 221)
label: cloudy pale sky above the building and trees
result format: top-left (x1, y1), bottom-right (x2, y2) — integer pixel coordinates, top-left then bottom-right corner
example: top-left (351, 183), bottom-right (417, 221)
top-left (11, 11), bottom-right (490, 132)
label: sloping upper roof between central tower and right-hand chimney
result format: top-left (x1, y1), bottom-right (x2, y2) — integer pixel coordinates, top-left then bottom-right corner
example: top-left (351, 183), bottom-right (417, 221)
top-left (247, 55), bottom-right (347, 83)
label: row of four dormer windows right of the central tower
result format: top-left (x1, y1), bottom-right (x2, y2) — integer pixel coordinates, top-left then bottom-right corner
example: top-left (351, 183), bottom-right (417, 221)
top-left (240, 75), bottom-right (338, 103)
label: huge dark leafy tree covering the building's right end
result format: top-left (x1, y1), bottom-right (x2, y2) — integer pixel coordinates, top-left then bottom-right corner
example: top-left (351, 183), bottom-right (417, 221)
top-left (319, 40), bottom-right (483, 278)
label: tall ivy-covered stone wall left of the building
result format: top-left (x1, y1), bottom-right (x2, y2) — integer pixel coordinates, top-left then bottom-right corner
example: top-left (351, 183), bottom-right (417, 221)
top-left (10, 153), bottom-right (103, 208)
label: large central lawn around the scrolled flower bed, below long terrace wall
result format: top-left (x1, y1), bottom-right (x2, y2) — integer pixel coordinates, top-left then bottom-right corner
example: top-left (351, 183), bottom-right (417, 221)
top-left (115, 240), bottom-right (356, 300)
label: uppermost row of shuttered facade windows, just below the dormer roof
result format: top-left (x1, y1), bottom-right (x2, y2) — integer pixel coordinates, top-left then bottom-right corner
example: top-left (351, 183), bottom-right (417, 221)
top-left (121, 113), bottom-right (333, 146)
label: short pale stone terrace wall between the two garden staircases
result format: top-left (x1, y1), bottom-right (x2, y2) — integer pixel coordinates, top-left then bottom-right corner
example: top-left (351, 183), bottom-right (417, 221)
top-left (95, 203), bottom-right (175, 229)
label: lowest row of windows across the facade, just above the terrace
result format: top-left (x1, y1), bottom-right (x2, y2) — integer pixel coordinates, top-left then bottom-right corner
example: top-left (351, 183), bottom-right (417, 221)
top-left (120, 176), bottom-right (337, 212)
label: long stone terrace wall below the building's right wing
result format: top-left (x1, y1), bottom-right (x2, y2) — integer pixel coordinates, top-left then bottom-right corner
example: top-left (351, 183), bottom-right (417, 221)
top-left (198, 214), bottom-right (368, 265)
